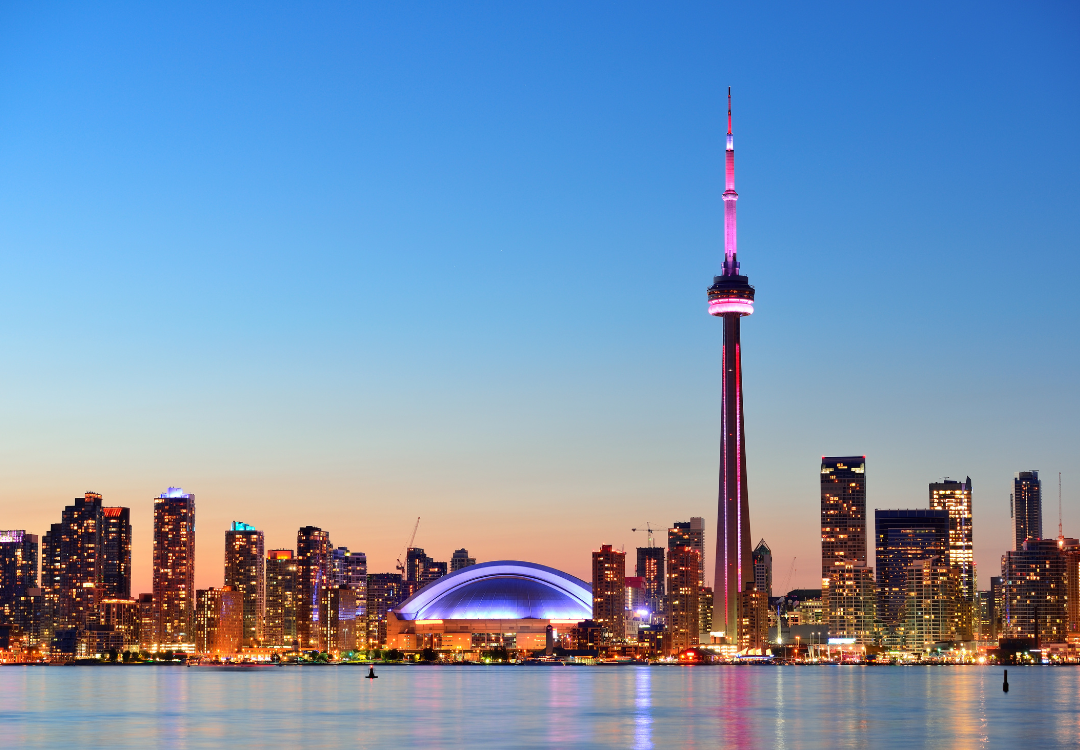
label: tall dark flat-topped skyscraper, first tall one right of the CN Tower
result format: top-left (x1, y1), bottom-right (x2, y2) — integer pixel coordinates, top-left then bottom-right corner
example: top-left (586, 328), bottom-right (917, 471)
top-left (821, 456), bottom-right (866, 581)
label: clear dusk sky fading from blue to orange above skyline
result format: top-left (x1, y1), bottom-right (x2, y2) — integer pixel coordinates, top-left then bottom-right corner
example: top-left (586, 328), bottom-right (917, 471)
top-left (0, 2), bottom-right (1080, 592)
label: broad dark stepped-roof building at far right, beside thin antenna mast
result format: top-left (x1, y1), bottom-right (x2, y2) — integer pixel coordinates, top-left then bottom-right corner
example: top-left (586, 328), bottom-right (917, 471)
top-left (1001, 538), bottom-right (1068, 643)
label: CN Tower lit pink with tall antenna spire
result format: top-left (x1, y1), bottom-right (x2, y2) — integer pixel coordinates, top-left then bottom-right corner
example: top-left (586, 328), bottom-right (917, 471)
top-left (708, 86), bottom-right (754, 644)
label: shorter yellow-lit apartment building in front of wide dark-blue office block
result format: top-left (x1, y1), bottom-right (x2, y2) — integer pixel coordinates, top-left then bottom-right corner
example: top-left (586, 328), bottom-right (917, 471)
top-left (904, 555), bottom-right (960, 651)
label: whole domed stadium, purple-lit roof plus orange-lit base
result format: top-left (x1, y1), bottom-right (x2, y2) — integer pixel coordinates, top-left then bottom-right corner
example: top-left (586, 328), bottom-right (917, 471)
top-left (387, 560), bottom-right (593, 652)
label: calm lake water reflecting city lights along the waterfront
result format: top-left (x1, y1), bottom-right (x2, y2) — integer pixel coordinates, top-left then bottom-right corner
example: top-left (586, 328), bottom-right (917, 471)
top-left (0, 666), bottom-right (1080, 749)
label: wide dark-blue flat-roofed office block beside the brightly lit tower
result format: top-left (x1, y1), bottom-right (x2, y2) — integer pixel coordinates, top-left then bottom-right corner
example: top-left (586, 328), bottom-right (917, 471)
top-left (874, 510), bottom-right (949, 629)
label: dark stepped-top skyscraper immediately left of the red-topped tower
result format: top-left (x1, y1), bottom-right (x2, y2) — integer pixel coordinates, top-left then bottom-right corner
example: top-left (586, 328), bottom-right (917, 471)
top-left (59, 492), bottom-right (105, 628)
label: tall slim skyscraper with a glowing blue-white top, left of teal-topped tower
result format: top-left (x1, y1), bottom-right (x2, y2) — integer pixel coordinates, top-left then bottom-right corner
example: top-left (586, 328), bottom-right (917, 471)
top-left (153, 487), bottom-right (195, 644)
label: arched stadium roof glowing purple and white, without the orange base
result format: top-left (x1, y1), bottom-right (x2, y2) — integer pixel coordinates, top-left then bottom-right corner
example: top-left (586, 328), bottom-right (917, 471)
top-left (393, 560), bottom-right (593, 620)
